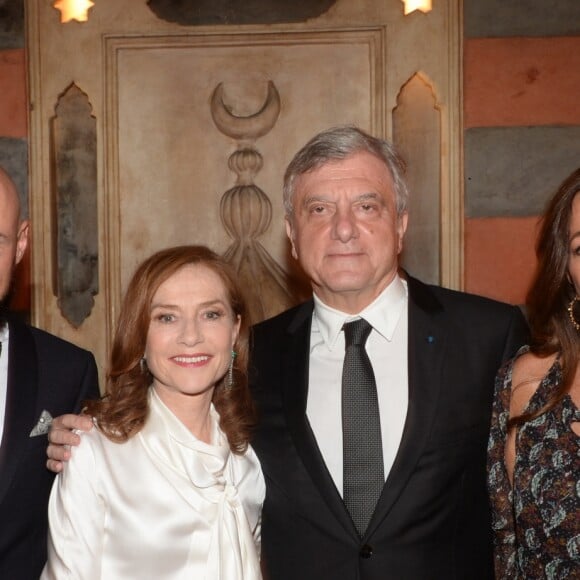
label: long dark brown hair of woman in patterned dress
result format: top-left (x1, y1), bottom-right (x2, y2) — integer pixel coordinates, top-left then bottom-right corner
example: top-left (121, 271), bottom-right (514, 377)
top-left (510, 168), bottom-right (580, 425)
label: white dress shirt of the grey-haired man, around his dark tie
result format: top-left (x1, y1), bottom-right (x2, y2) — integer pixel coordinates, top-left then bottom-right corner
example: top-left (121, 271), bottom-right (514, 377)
top-left (306, 276), bottom-right (409, 495)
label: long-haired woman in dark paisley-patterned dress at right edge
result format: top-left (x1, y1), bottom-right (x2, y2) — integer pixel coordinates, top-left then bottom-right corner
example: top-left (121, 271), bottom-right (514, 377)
top-left (488, 168), bottom-right (580, 579)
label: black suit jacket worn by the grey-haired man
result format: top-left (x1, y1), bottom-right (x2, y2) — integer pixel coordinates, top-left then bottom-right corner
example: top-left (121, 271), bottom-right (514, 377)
top-left (252, 278), bottom-right (526, 580)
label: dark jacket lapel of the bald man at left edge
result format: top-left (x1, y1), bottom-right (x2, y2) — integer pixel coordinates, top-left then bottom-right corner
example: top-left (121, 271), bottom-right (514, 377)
top-left (0, 321), bottom-right (38, 502)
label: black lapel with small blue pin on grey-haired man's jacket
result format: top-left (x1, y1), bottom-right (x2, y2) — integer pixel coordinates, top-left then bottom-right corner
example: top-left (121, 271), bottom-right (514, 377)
top-left (366, 278), bottom-right (447, 536)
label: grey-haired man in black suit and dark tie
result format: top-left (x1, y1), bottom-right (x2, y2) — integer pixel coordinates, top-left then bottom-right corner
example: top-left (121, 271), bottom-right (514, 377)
top-left (49, 127), bottom-right (526, 580)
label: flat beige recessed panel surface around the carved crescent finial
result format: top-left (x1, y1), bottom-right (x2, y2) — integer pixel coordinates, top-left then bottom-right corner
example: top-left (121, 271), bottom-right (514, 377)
top-left (105, 28), bottom-right (385, 308)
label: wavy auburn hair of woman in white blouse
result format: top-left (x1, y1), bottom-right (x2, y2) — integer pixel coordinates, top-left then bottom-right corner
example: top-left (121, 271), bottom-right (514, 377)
top-left (87, 246), bottom-right (255, 453)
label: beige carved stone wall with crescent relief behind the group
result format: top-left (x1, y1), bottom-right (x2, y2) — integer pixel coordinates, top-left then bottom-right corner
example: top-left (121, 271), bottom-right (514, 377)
top-left (26, 0), bottom-right (462, 366)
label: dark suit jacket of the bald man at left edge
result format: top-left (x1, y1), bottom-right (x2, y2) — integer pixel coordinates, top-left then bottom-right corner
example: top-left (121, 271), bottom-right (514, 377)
top-left (0, 318), bottom-right (99, 580)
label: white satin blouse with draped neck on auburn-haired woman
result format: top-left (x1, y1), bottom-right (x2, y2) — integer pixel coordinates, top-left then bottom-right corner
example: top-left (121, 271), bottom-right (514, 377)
top-left (41, 389), bottom-right (265, 580)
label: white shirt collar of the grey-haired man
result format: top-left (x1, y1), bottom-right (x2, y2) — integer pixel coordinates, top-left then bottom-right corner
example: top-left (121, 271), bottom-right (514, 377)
top-left (313, 275), bottom-right (408, 350)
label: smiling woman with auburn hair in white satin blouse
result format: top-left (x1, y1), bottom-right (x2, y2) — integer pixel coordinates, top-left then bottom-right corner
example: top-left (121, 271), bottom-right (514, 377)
top-left (42, 246), bottom-right (265, 580)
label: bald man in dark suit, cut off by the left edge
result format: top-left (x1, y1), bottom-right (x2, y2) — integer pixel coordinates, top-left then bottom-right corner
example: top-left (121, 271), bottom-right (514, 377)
top-left (0, 168), bottom-right (99, 580)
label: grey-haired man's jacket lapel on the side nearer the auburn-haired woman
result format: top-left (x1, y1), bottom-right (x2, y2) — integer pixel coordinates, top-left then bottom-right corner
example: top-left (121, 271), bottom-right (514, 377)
top-left (282, 301), bottom-right (356, 536)
